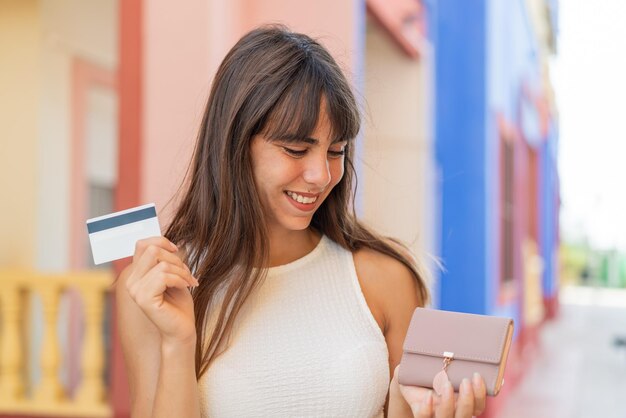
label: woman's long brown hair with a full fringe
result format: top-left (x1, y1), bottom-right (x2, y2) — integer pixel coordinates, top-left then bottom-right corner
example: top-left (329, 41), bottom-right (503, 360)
top-left (165, 26), bottom-right (428, 378)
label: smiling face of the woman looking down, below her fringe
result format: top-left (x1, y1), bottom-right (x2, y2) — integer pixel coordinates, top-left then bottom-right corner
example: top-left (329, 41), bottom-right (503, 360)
top-left (250, 106), bottom-right (347, 232)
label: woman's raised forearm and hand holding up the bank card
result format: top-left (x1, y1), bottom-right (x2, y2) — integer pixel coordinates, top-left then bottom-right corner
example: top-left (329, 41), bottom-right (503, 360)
top-left (116, 237), bottom-right (200, 418)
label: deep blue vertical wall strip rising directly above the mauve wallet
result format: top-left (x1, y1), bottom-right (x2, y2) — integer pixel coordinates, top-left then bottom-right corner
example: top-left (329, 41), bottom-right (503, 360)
top-left (432, 0), bottom-right (487, 312)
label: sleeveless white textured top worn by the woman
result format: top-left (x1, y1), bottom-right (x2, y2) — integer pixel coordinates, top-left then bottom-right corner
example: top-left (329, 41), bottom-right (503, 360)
top-left (198, 236), bottom-right (389, 418)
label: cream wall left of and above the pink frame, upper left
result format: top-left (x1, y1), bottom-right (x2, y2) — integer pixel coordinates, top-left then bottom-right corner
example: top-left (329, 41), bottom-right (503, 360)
top-left (36, 0), bottom-right (118, 271)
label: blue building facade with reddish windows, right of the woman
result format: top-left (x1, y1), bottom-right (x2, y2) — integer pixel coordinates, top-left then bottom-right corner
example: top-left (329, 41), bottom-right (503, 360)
top-left (432, 0), bottom-right (559, 416)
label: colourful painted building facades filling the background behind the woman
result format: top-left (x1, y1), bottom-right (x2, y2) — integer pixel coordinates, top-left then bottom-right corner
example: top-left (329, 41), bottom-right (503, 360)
top-left (0, 0), bottom-right (558, 417)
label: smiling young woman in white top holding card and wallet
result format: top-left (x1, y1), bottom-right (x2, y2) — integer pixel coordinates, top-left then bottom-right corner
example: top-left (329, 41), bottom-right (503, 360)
top-left (117, 26), bottom-right (485, 418)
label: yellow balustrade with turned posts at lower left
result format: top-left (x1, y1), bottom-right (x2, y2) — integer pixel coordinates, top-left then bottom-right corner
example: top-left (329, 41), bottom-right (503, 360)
top-left (0, 271), bottom-right (113, 418)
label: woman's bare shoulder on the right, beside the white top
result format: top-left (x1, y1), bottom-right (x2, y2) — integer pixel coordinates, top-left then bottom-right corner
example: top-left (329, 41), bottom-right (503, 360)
top-left (353, 243), bottom-right (424, 333)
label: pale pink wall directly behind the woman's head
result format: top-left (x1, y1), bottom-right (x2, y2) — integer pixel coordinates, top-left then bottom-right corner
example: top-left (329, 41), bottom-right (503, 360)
top-left (140, 0), bottom-right (364, 226)
